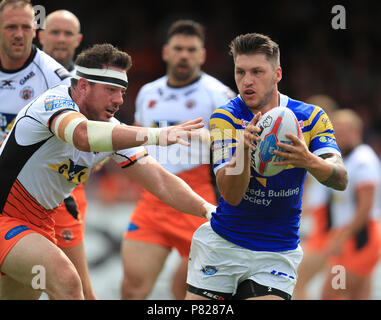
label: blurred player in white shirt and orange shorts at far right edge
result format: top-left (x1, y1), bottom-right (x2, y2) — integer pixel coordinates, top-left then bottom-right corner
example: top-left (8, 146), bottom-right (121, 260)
top-left (296, 109), bottom-right (381, 300)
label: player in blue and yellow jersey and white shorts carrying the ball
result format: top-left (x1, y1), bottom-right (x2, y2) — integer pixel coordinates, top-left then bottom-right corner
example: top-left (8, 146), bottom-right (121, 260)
top-left (187, 33), bottom-right (348, 299)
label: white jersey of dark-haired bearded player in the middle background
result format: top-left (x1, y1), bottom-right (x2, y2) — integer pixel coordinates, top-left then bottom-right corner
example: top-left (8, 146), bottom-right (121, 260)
top-left (135, 73), bottom-right (235, 174)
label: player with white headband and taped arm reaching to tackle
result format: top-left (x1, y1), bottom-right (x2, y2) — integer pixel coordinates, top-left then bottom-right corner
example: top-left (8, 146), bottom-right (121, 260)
top-left (0, 44), bottom-right (214, 299)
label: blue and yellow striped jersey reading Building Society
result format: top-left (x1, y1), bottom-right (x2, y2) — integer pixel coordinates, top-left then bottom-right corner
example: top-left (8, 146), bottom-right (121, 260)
top-left (210, 94), bottom-right (340, 251)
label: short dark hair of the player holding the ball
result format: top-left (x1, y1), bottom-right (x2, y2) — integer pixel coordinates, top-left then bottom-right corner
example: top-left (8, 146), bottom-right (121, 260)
top-left (229, 33), bottom-right (280, 67)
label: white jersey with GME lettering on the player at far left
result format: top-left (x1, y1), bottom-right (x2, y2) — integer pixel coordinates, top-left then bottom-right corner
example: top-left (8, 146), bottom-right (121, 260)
top-left (0, 46), bottom-right (70, 141)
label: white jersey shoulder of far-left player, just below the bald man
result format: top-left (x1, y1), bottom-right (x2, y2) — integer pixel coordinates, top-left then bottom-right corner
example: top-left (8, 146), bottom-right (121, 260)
top-left (33, 48), bottom-right (70, 80)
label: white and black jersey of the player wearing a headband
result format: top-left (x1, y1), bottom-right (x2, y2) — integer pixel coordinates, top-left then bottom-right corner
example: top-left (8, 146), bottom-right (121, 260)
top-left (0, 85), bottom-right (146, 212)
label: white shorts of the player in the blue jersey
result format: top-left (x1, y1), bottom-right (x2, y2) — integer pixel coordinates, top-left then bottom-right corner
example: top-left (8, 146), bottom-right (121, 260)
top-left (187, 222), bottom-right (303, 295)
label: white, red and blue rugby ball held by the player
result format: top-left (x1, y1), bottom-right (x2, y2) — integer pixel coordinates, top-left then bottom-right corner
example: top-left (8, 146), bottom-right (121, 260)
top-left (250, 107), bottom-right (300, 177)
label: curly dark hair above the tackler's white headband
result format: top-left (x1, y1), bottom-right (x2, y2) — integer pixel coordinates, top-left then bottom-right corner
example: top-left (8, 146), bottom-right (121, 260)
top-left (71, 43), bottom-right (132, 87)
